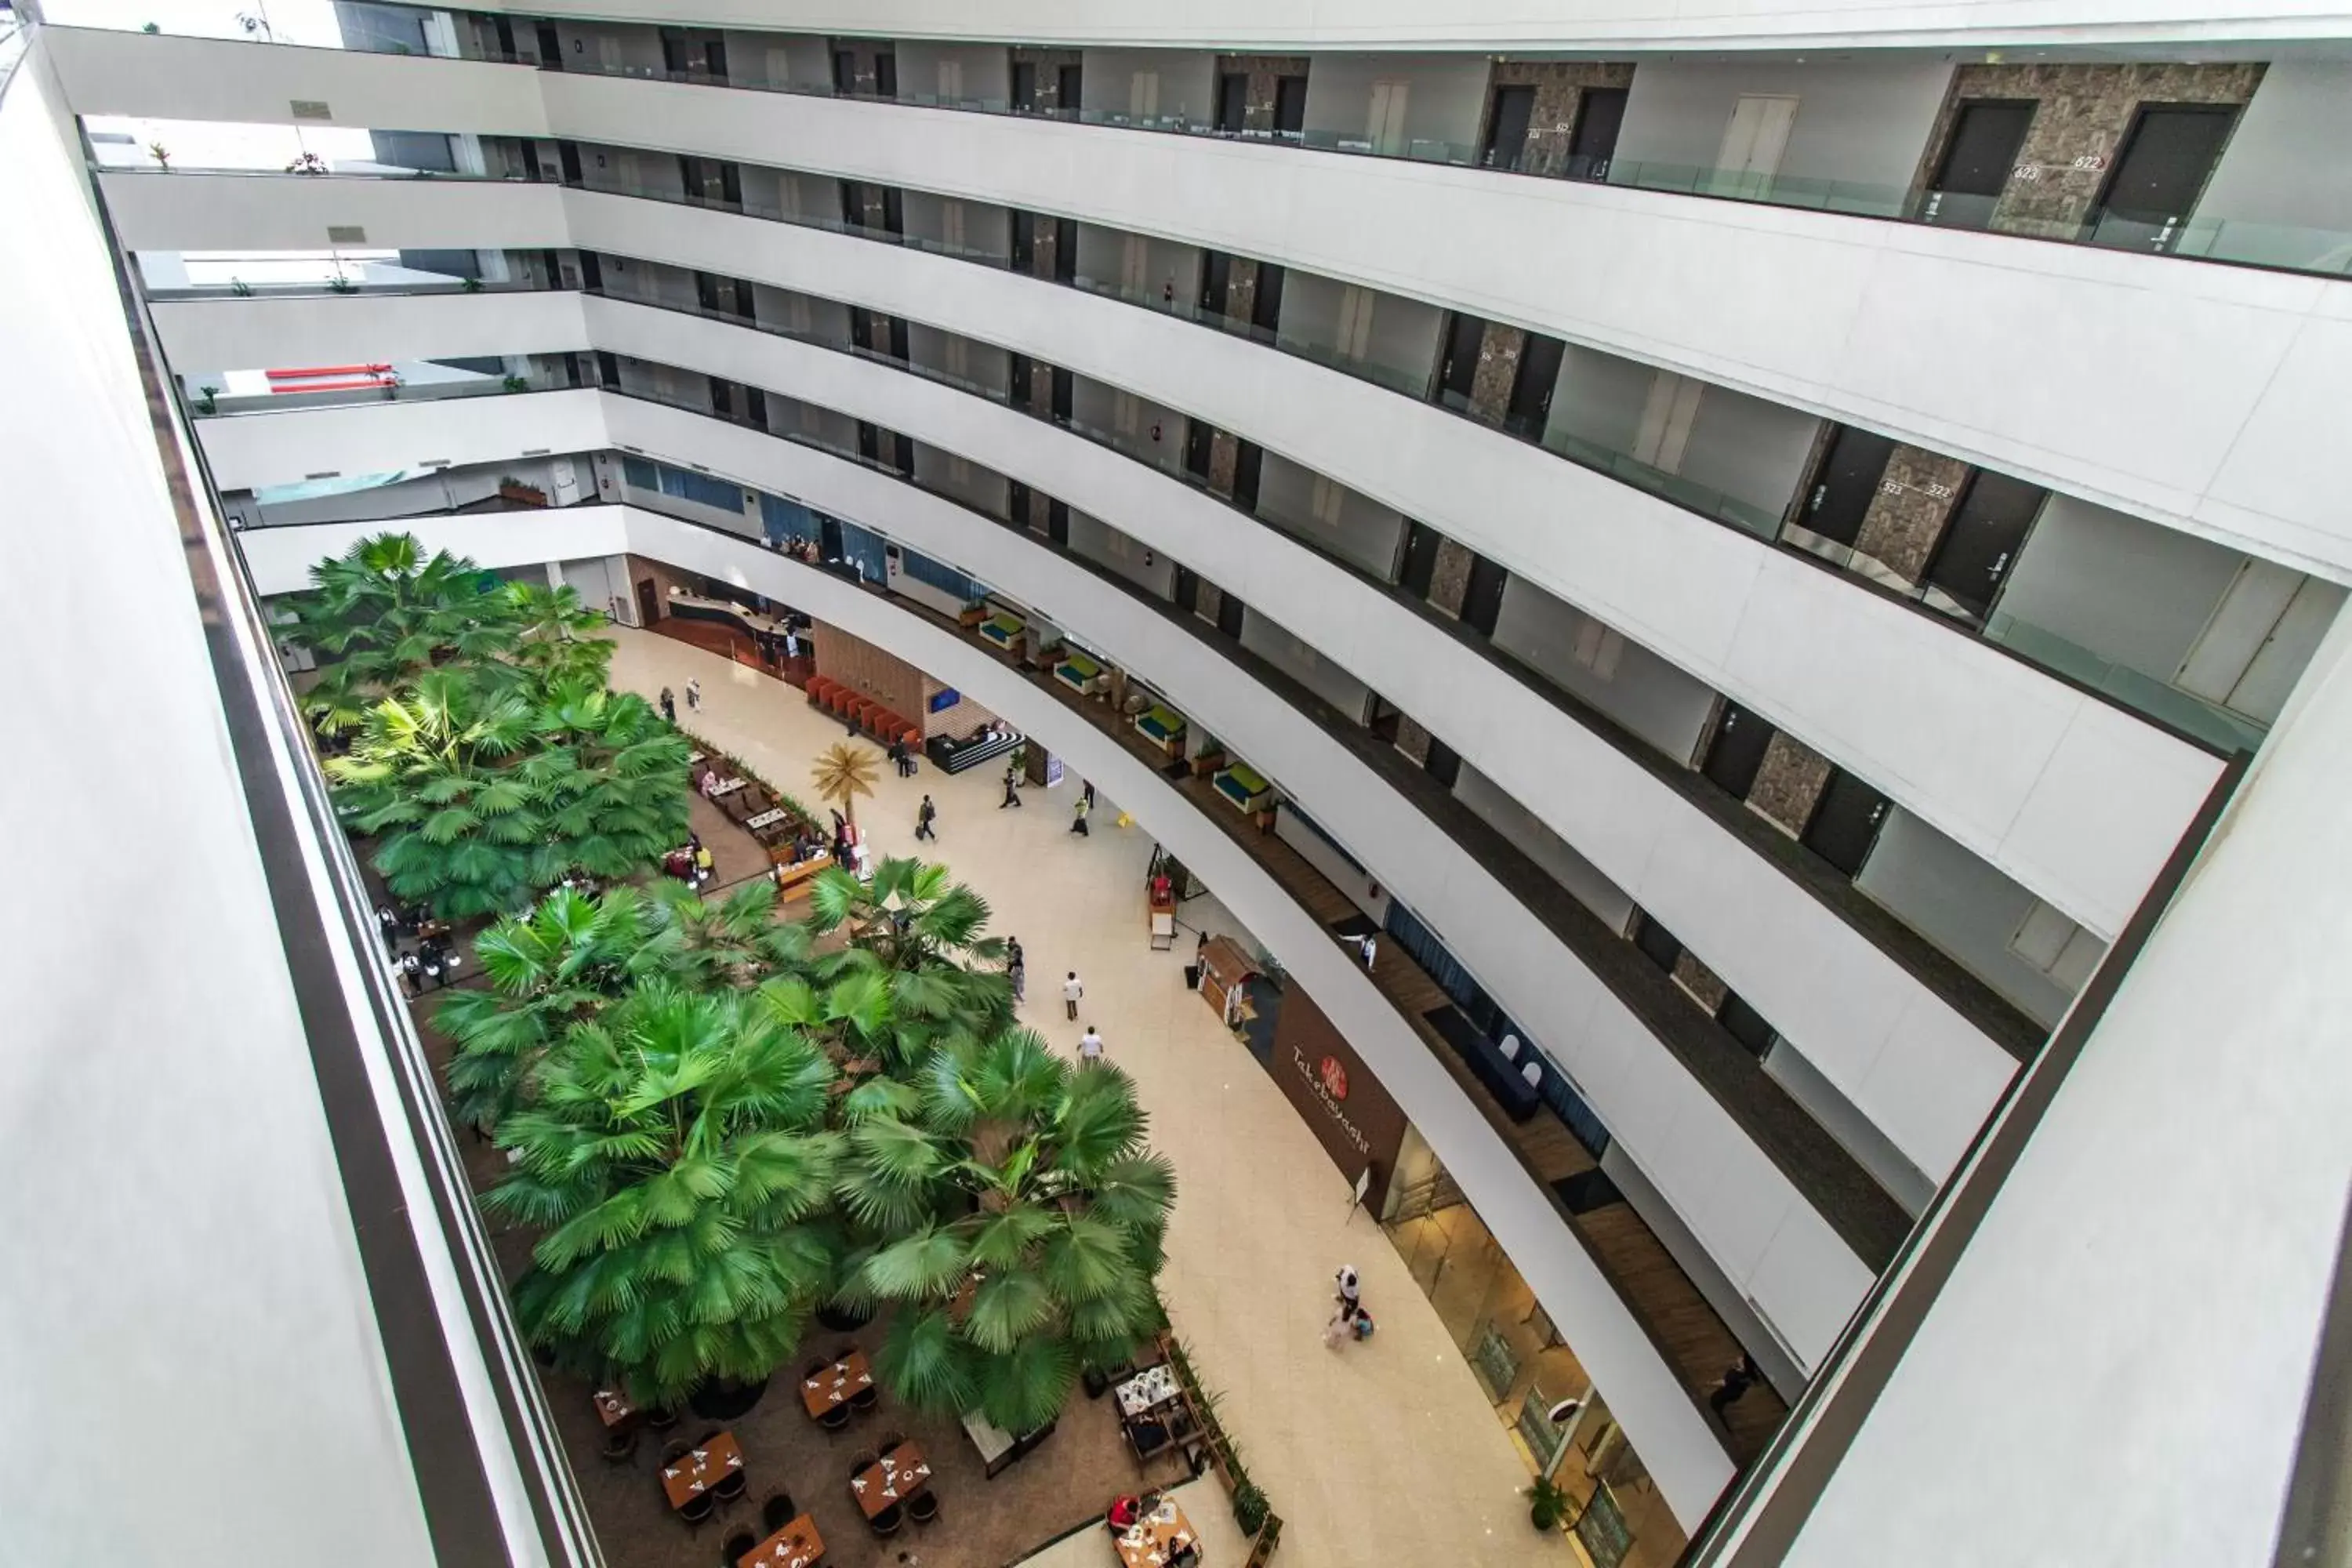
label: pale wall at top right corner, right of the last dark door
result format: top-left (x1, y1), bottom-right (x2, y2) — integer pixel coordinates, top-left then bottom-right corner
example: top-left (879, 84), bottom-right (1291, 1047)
top-left (2190, 59), bottom-right (2352, 270)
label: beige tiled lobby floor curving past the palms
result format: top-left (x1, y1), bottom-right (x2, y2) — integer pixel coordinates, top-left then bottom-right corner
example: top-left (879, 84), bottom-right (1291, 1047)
top-left (612, 628), bottom-right (1571, 1568)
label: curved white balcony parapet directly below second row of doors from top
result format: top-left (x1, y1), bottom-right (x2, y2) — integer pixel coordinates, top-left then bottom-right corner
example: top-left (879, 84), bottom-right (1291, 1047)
top-left (108, 176), bottom-right (2230, 949)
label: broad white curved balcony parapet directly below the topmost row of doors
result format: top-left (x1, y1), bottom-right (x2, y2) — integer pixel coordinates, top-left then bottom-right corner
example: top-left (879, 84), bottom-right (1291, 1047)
top-left (59, 26), bottom-right (2352, 576)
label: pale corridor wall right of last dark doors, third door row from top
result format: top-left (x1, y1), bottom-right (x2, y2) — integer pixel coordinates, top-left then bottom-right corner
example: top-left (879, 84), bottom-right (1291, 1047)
top-left (1853, 806), bottom-right (2074, 1025)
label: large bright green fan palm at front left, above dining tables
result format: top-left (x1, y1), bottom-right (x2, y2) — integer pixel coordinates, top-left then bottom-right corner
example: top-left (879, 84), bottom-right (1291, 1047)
top-left (485, 980), bottom-right (842, 1406)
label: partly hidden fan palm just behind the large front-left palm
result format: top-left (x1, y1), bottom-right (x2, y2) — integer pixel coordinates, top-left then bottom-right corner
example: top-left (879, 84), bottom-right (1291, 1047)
top-left (433, 886), bottom-right (670, 1131)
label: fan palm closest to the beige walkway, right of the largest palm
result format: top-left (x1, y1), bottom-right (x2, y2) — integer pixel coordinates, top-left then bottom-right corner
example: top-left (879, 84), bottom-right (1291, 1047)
top-left (840, 1029), bottom-right (1176, 1432)
